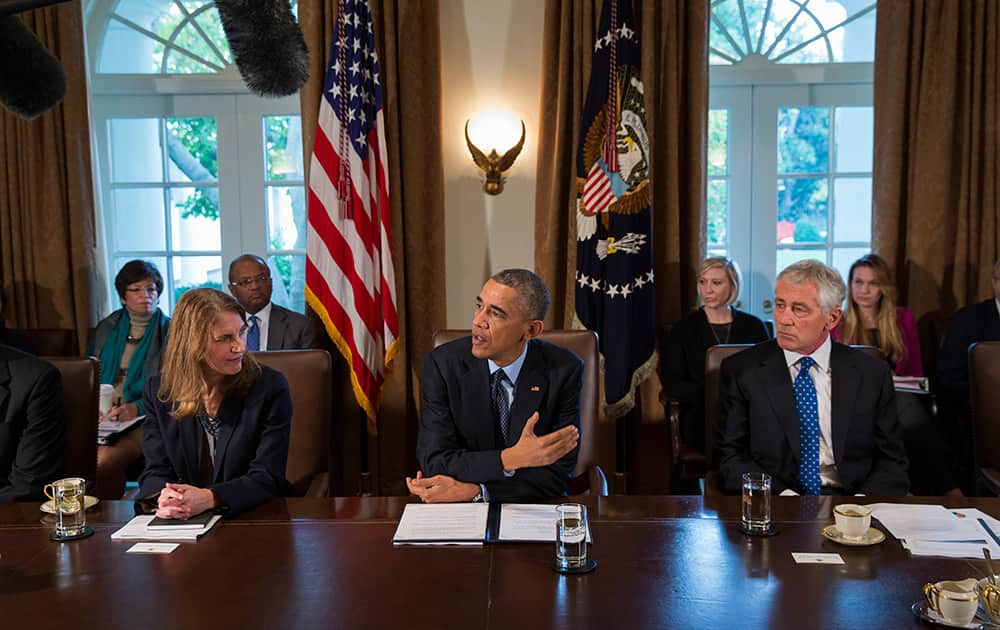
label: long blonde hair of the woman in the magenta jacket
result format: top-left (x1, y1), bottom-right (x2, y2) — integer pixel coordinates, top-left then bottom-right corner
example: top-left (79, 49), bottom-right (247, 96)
top-left (843, 254), bottom-right (906, 363)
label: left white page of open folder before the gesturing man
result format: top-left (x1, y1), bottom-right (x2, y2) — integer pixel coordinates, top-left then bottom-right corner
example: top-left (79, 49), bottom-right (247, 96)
top-left (392, 503), bottom-right (490, 545)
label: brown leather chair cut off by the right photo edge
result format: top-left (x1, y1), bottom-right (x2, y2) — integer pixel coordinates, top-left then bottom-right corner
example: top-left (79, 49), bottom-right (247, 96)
top-left (969, 341), bottom-right (1000, 495)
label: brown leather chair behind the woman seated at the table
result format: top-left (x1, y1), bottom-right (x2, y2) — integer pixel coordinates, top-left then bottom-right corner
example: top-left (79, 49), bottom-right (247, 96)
top-left (253, 350), bottom-right (333, 497)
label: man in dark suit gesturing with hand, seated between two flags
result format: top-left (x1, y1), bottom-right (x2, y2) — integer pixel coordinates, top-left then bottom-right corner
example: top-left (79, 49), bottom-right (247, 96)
top-left (406, 269), bottom-right (583, 503)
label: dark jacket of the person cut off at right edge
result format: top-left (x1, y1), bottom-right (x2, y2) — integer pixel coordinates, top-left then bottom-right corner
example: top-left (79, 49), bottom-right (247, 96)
top-left (936, 298), bottom-right (1000, 401)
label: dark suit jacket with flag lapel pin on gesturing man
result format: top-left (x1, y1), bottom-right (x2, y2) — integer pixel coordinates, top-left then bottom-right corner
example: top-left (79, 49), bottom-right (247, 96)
top-left (417, 337), bottom-right (583, 501)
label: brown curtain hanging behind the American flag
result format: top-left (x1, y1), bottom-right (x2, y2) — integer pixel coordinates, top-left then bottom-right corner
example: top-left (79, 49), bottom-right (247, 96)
top-left (299, 0), bottom-right (446, 494)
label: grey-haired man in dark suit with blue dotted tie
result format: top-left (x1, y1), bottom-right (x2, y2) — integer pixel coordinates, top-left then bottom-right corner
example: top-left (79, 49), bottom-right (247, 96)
top-left (716, 260), bottom-right (909, 496)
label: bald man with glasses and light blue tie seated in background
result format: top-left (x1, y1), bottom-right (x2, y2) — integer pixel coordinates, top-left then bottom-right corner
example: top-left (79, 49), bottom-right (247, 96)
top-left (229, 254), bottom-right (318, 352)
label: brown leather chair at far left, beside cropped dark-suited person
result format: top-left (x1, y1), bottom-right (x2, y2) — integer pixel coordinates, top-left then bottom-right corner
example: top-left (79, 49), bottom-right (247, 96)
top-left (44, 357), bottom-right (101, 486)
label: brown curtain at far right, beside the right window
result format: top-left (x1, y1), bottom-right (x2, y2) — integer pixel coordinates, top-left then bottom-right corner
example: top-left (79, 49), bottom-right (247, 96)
top-left (873, 0), bottom-right (1000, 362)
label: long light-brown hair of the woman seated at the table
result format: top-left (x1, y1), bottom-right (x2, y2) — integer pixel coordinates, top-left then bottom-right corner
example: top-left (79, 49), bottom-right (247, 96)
top-left (157, 289), bottom-right (260, 420)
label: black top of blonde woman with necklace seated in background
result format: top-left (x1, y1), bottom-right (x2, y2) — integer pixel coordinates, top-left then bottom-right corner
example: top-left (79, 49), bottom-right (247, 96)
top-left (663, 308), bottom-right (767, 449)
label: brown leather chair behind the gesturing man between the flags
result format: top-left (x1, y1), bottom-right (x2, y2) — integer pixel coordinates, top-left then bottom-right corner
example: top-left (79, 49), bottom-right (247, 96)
top-left (432, 330), bottom-right (608, 497)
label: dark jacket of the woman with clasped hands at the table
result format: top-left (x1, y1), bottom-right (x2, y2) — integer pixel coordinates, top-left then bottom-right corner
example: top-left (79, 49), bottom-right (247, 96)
top-left (139, 366), bottom-right (292, 514)
